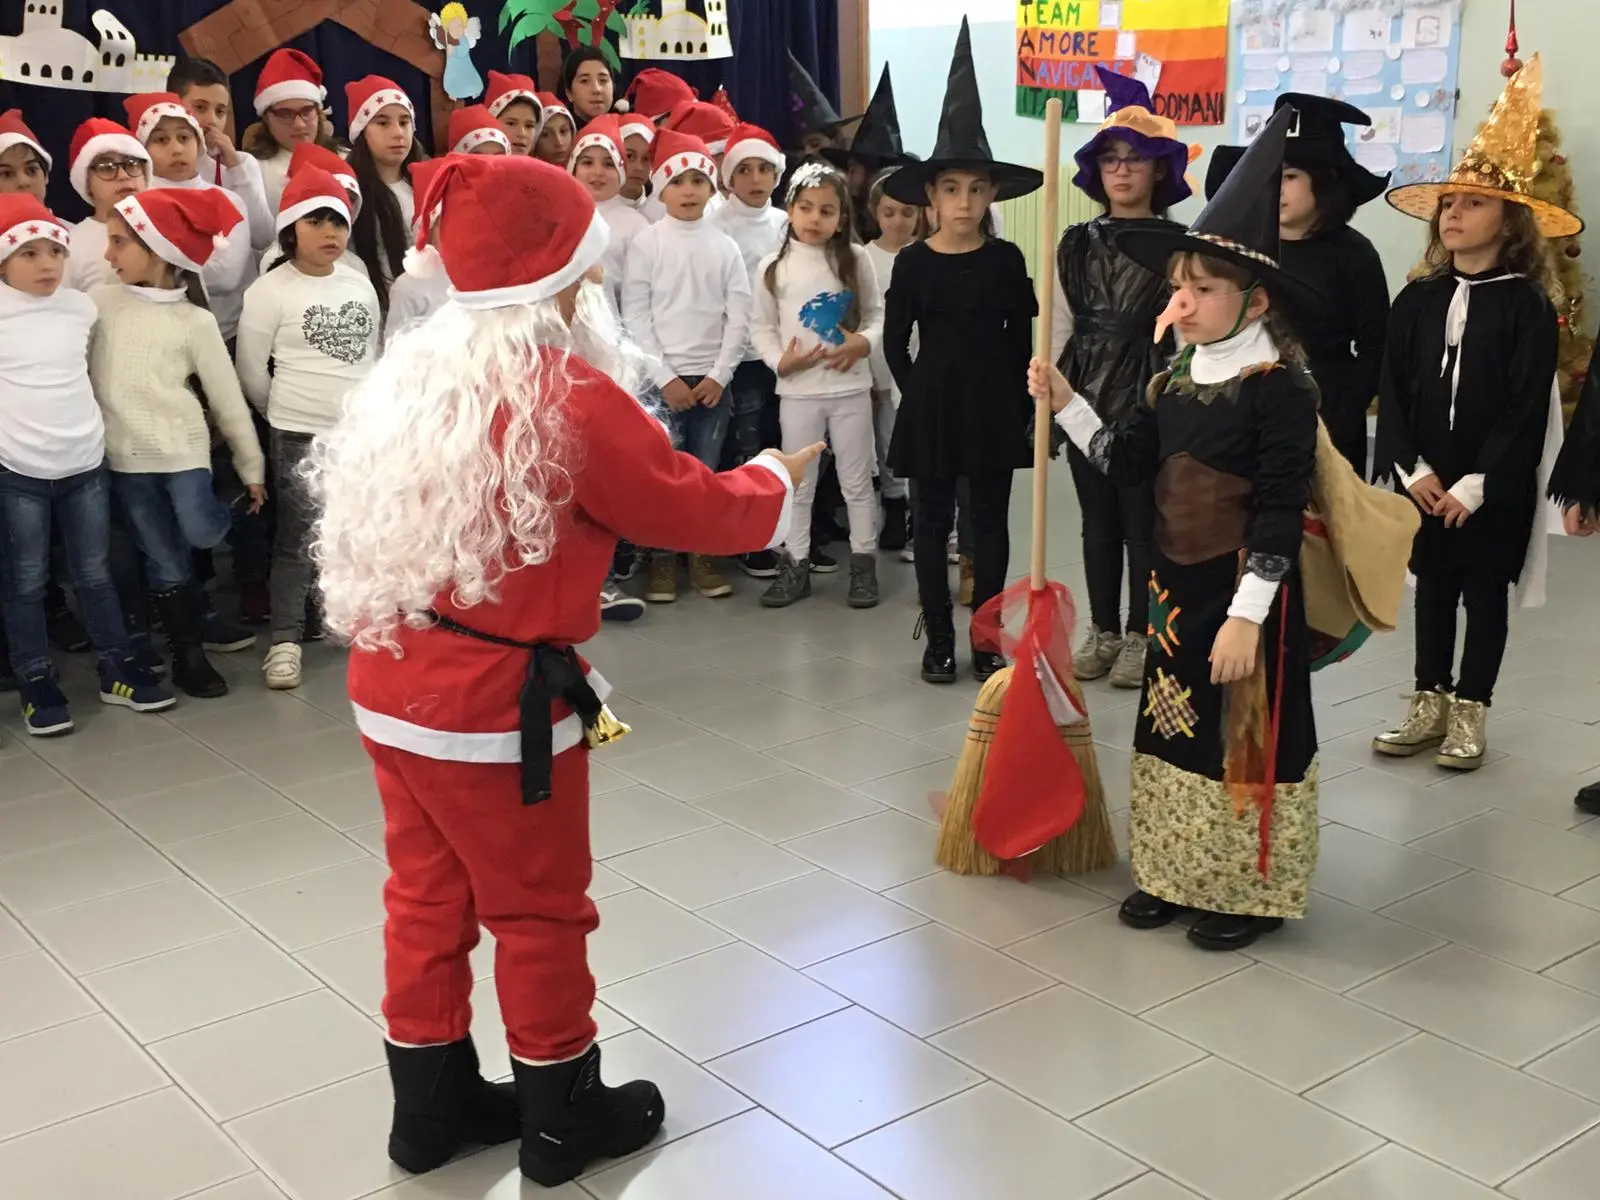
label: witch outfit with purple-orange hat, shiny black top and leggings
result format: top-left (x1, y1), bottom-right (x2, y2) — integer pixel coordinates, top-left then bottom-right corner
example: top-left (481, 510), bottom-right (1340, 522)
top-left (1051, 67), bottom-right (1198, 688)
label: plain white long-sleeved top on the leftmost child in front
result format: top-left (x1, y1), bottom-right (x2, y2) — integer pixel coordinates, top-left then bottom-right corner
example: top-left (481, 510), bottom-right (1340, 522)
top-left (0, 285), bottom-right (106, 478)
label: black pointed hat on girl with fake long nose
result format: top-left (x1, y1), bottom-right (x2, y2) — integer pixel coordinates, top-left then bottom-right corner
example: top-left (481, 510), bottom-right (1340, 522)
top-left (1112, 109), bottom-right (1322, 304)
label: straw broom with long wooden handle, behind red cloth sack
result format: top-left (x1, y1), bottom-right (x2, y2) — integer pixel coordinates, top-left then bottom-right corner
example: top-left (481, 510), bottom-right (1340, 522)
top-left (936, 99), bottom-right (1117, 875)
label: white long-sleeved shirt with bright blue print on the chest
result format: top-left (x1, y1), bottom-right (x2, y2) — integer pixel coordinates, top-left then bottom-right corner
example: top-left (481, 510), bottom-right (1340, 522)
top-left (750, 238), bottom-right (883, 398)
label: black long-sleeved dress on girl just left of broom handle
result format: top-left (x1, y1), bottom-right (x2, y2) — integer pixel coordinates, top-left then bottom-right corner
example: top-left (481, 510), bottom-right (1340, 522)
top-left (883, 238), bottom-right (1038, 480)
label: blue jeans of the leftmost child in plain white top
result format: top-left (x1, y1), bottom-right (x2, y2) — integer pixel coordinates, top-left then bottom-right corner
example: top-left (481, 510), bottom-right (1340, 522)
top-left (0, 467), bottom-right (128, 678)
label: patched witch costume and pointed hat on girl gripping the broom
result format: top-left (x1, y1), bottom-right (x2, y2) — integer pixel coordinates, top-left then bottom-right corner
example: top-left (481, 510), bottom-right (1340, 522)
top-left (1056, 112), bottom-right (1317, 950)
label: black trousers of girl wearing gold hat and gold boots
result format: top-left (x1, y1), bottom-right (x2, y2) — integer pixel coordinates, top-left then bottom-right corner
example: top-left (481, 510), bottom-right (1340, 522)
top-left (1416, 566), bottom-right (1510, 704)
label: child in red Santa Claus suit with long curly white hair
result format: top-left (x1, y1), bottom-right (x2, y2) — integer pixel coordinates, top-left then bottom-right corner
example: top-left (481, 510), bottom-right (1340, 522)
top-left (315, 157), bottom-right (806, 1186)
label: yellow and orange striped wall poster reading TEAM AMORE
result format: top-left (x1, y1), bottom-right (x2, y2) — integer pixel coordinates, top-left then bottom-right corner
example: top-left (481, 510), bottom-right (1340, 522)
top-left (1016, 0), bottom-right (1227, 125)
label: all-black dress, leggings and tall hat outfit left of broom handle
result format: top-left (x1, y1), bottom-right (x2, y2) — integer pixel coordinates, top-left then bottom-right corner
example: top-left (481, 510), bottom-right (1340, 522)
top-left (883, 19), bottom-right (1045, 683)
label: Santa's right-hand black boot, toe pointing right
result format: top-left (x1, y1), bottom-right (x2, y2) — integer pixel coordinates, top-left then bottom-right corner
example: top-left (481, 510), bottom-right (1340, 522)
top-left (510, 1043), bottom-right (667, 1187)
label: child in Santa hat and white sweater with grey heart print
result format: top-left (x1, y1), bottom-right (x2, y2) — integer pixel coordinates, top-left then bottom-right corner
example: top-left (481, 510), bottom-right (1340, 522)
top-left (237, 168), bottom-right (381, 690)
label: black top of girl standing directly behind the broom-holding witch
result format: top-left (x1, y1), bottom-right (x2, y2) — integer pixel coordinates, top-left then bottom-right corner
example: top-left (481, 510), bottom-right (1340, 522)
top-left (1272, 226), bottom-right (1389, 475)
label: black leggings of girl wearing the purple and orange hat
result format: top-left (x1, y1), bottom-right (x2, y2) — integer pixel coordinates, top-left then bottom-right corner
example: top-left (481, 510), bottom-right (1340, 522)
top-left (1067, 445), bottom-right (1155, 634)
